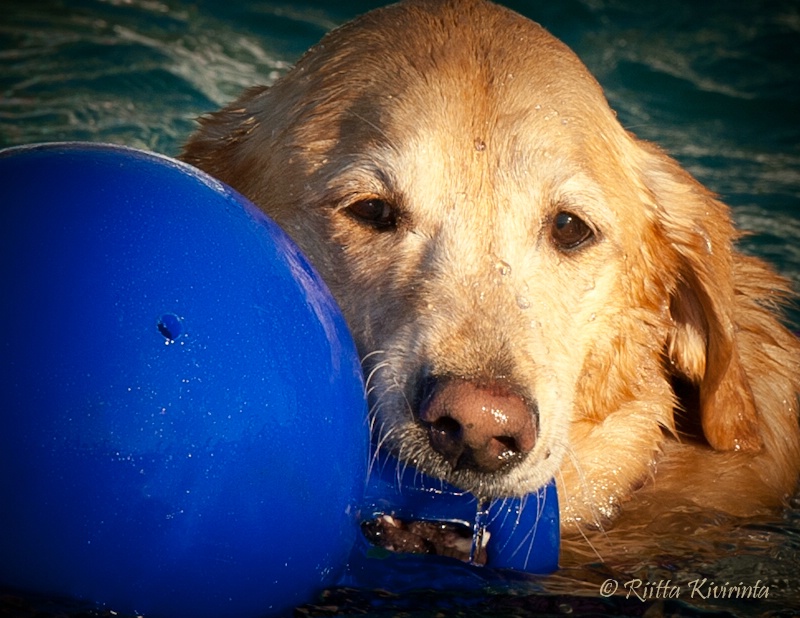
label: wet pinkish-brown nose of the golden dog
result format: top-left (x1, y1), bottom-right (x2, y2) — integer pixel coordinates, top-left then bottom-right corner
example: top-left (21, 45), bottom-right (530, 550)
top-left (419, 379), bottom-right (536, 472)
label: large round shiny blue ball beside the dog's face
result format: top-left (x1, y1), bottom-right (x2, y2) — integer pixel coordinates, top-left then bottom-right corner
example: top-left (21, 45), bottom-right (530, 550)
top-left (0, 144), bottom-right (369, 617)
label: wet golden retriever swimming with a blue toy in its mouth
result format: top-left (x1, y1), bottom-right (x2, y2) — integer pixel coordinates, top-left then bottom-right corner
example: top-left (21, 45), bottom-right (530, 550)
top-left (183, 0), bottom-right (800, 548)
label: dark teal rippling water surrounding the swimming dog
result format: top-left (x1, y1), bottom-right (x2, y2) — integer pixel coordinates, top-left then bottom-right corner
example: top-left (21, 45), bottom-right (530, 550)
top-left (0, 0), bottom-right (800, 617)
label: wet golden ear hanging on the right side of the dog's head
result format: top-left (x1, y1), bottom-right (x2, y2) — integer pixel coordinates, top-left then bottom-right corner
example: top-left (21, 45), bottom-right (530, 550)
top-left (643, 145), bottom-right (762, 452)
